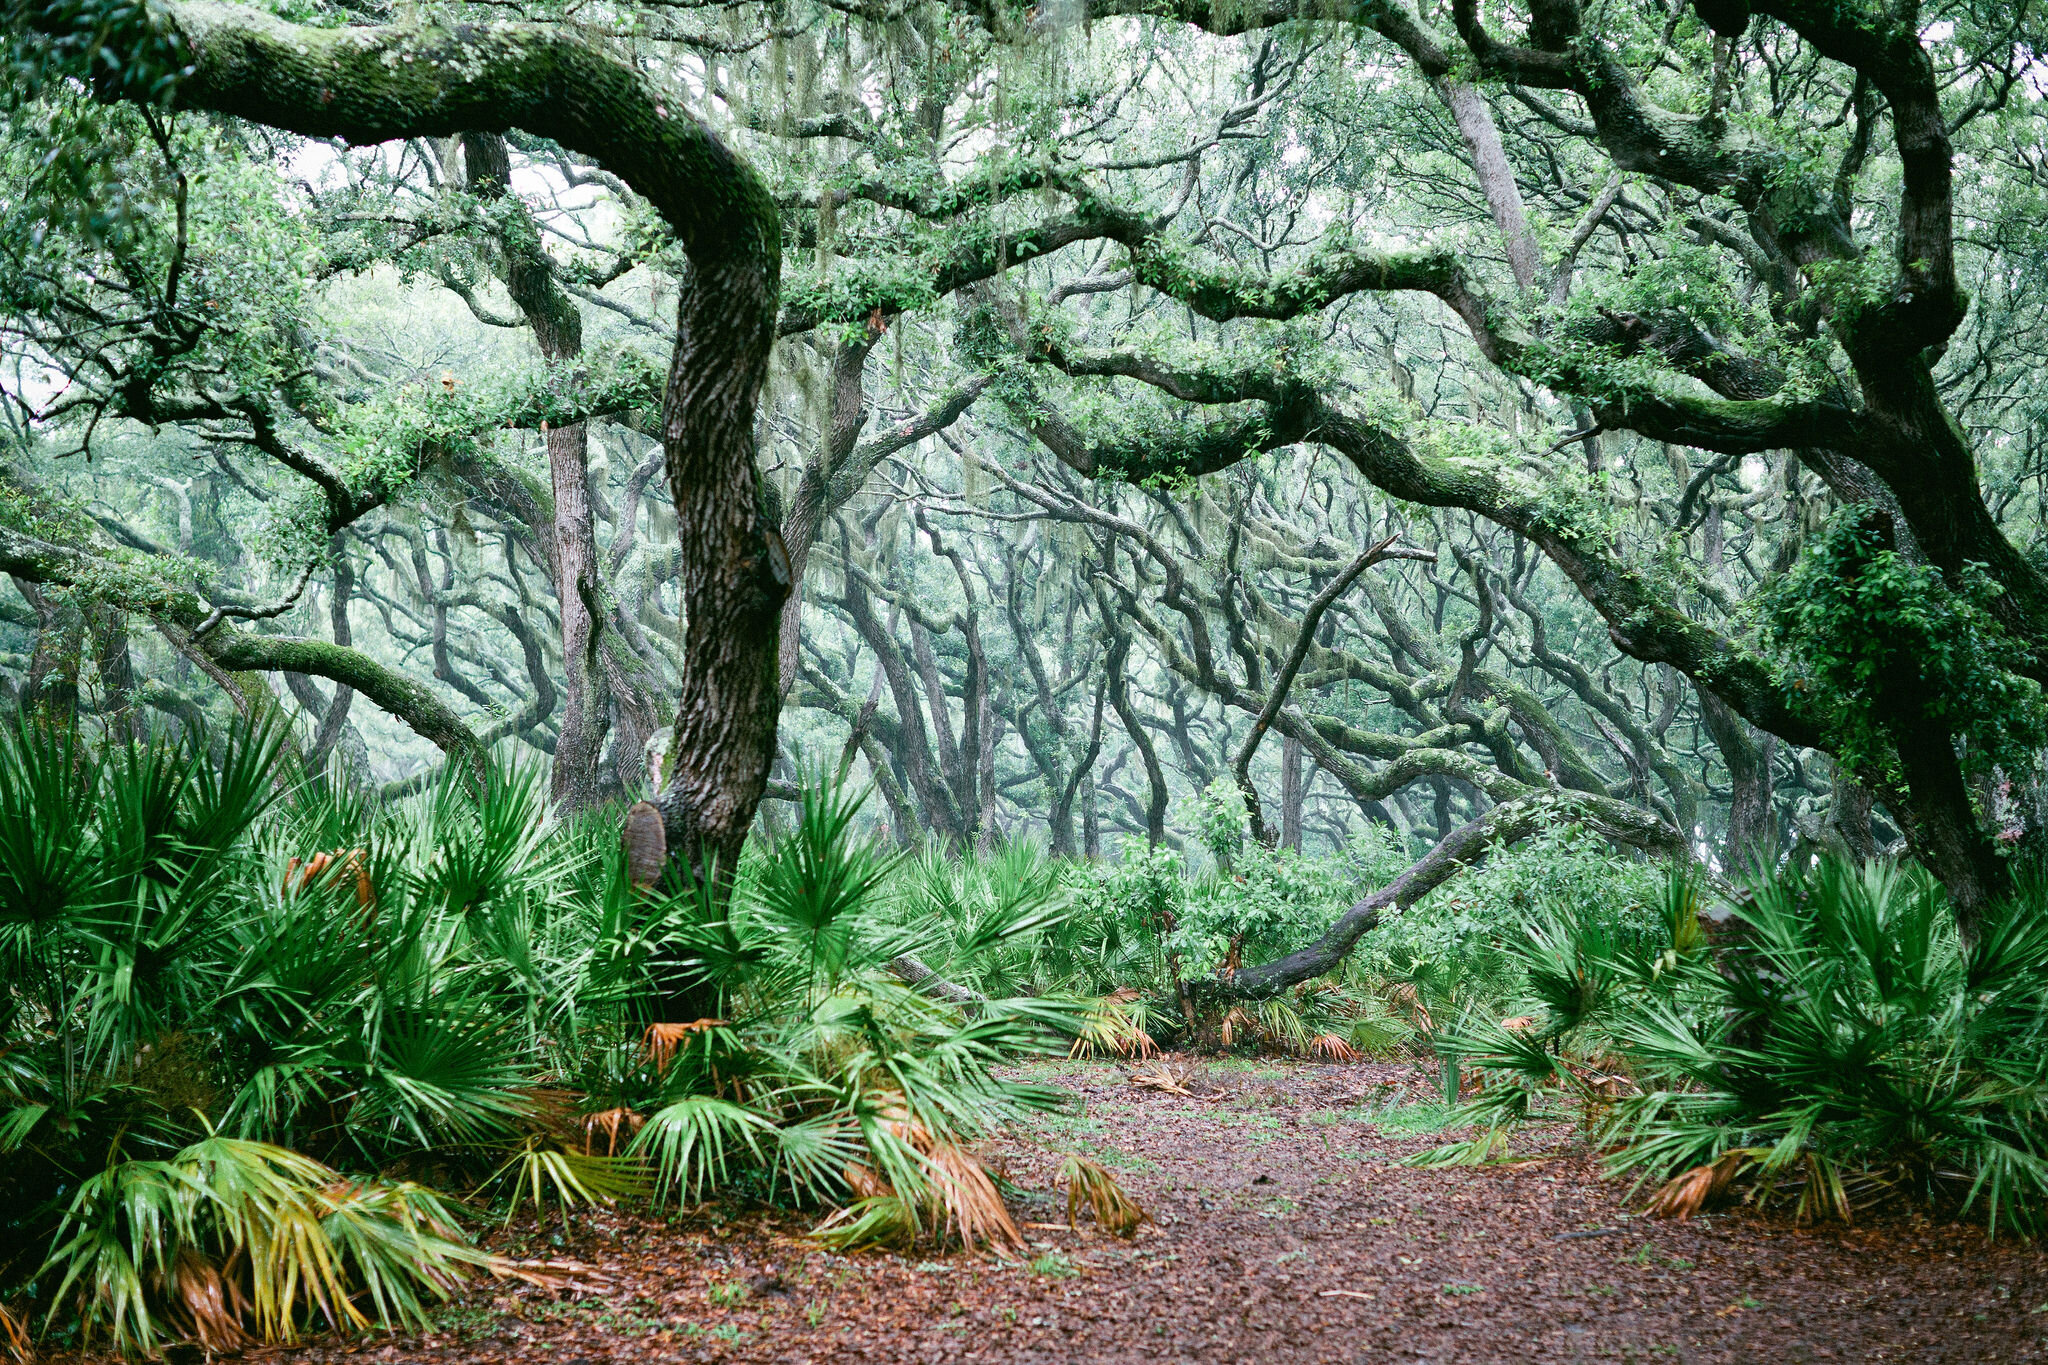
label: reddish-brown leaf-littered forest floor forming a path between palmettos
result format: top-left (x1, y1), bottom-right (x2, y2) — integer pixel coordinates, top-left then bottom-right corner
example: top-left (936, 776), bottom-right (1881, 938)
top-left (264, 1062), bottom-right (2048, 1365)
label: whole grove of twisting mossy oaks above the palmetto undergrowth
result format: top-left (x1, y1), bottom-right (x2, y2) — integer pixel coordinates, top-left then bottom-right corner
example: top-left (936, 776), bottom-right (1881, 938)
top-left (4, 2), bottom-right (2048, 993)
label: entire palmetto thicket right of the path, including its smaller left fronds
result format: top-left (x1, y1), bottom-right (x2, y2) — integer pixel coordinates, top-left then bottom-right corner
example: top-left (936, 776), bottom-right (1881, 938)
top-left (1427, 860), bottom-right (2048, 1234)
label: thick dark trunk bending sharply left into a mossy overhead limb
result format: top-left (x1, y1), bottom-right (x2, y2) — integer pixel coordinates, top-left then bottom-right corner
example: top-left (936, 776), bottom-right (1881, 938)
top-left (6, 4), bottom-right (788, 868)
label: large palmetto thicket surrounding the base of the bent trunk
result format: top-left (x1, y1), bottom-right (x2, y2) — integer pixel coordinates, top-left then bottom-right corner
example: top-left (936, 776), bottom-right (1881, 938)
top-left (0, 722), bottom-right (1083, 1355)
